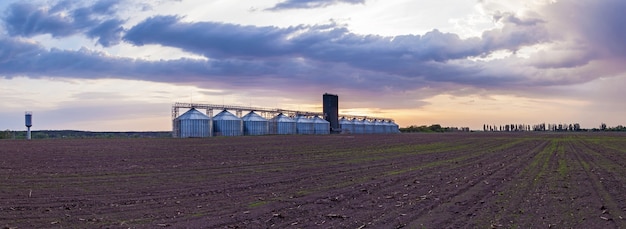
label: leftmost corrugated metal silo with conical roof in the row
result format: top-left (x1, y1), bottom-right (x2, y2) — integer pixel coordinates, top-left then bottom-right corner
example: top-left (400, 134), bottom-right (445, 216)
top-left (174, 108), bottom-right (211, 138)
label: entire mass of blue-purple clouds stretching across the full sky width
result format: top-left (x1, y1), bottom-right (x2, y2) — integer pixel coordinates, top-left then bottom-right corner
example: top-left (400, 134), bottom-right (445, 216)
top-left (0, 1), bottom-right (626, 112)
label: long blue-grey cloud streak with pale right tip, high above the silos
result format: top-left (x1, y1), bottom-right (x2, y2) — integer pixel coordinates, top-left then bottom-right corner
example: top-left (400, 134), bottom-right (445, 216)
top-left (123, 16), bottom-right (547, 86)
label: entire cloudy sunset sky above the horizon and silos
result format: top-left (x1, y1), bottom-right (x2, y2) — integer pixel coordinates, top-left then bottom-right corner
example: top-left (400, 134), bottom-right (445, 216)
top-left (0, 0), bottom-right (626, 131)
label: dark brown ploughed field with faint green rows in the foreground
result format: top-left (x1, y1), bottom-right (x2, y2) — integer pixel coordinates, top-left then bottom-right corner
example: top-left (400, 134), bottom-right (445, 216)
top-left (0, 133), bottom-right (626, 228)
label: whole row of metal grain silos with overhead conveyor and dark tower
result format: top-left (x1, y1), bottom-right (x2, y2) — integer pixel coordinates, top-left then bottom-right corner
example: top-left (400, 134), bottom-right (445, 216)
top-left (172, 93), bottom-right (400, 138)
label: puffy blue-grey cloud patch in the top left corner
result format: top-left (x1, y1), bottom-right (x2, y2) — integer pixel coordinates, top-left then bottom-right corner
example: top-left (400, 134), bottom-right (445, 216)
top-left (2, 0), bottom-right (124, 47)
